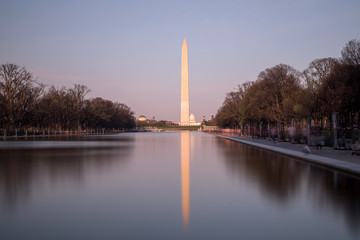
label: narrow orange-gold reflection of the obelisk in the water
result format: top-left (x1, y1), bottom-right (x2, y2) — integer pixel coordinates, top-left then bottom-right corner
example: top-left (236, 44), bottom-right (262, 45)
top-left (181, 131), bottom-right (190, 229)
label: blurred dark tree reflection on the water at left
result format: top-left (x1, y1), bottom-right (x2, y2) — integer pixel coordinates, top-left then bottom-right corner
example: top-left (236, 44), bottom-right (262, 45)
top-left (0, 142), bottom-right (132, 209)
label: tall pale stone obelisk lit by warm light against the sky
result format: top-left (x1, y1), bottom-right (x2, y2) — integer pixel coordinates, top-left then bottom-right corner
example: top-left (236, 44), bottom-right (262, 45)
top-left (180, 38), bottom-right (190, 126)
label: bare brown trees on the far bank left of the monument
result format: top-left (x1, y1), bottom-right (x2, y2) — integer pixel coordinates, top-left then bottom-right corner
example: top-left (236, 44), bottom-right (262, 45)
top-left (0, 64), bottom-right (135, 135)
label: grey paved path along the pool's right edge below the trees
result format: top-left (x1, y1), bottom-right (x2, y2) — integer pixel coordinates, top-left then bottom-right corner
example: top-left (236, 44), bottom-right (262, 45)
top-left (215, 134), bottom-right (360, 176)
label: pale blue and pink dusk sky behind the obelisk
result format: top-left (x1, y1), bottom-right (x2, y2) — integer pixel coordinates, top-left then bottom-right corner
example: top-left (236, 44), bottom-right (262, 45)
top-left (0, 0), bottom-right (360, 122)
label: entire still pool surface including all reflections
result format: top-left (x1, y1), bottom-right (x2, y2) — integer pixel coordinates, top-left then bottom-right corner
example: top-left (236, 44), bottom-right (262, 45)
top-left (0, 132), bottom-right (360, 239)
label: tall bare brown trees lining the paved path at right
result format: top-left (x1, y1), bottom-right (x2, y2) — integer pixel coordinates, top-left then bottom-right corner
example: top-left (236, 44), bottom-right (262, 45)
top-left (216, 39), bottom-right (360, 144)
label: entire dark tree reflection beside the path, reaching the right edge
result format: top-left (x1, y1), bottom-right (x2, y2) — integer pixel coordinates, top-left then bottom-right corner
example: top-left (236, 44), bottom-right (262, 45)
top-left (219, 139), bottom-right (360, 234)
